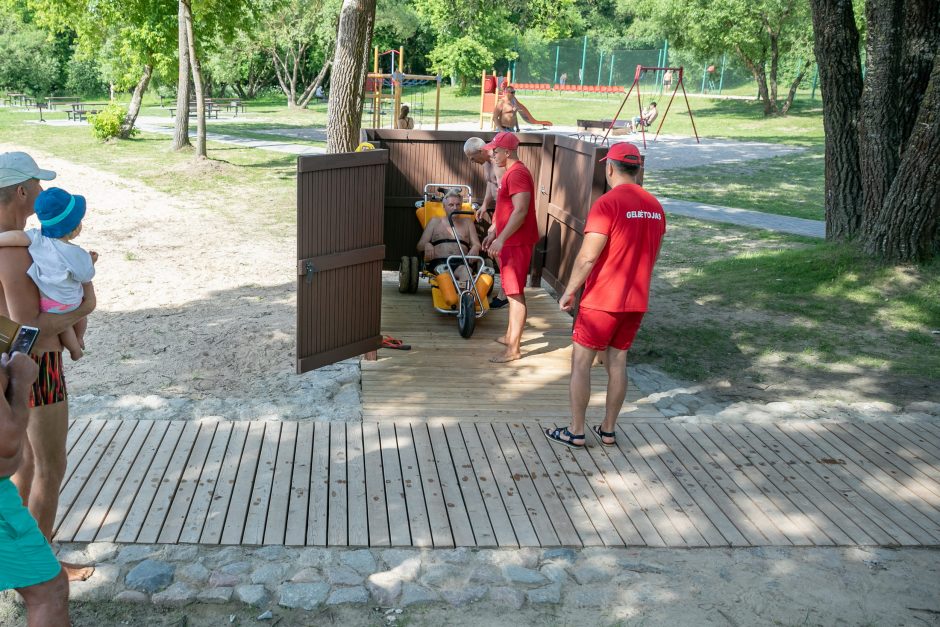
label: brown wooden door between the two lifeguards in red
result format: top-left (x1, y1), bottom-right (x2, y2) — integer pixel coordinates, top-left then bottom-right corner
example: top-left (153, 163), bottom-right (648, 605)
top-left (533, 135), bottom-right (607, 295)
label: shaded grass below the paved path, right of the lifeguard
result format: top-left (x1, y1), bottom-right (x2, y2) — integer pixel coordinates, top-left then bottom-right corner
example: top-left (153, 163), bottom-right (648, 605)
top-left (632, 216), bottom-right (940, 391)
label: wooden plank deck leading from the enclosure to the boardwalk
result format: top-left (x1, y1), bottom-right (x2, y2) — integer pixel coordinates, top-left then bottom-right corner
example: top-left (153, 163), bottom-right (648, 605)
top-left (362, 282), bottom-right (663, 422)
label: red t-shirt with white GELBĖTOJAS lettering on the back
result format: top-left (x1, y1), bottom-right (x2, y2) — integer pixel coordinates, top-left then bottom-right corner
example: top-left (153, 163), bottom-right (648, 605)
top-left (581, 184), bottom-right (666, 311)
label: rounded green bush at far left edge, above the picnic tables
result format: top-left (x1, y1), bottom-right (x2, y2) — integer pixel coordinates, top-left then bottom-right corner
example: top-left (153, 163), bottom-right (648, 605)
top-left (0, 17), bottom-right (61, 96)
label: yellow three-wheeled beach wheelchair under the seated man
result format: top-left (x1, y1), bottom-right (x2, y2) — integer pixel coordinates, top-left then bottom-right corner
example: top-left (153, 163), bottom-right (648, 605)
top-left (398, 183), bottom-right (495, 338)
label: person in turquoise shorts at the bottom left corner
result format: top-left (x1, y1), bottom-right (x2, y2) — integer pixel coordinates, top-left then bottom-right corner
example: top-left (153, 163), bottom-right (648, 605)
top-left (0, 353), bottom-right (69, 627)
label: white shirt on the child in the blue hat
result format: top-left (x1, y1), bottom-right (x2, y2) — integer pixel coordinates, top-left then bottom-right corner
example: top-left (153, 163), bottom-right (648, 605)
top-left (26, 229), bottom-right (95, 305)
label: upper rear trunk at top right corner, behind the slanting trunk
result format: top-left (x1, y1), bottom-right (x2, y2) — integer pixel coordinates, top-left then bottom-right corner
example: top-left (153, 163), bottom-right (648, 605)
top-left (899, 0), bottom-right (940, 145)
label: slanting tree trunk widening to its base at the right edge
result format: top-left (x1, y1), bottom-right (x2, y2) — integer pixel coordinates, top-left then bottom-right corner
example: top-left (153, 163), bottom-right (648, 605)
top-left (864, 54), bottom-right (940, 261)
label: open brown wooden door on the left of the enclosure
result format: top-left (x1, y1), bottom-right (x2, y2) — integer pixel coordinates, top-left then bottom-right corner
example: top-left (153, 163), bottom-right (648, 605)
top-left (297, 150), bottom-right (388, 373)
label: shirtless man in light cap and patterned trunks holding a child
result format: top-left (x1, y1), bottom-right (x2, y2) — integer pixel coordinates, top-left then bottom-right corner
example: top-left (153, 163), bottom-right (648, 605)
top-left (0, 152), bottom-right (96, 581)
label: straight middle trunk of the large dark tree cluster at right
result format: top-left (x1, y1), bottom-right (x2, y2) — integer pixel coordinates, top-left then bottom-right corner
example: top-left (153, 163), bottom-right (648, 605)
top-left (859, 0), bottom-right (903, 238)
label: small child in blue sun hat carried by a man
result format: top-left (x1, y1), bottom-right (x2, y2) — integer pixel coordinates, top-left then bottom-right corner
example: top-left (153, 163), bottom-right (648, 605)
top-left (0, 187), bottom-right (98, 360)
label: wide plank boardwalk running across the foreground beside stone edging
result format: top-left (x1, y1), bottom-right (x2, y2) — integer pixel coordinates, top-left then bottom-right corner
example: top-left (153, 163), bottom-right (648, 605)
top-left (56, 419), bottom-right (940, 547)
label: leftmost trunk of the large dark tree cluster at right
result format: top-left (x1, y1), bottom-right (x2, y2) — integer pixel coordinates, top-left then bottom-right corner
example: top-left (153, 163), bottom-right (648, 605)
top-left (811, 0), bottom-right (862, 241)
